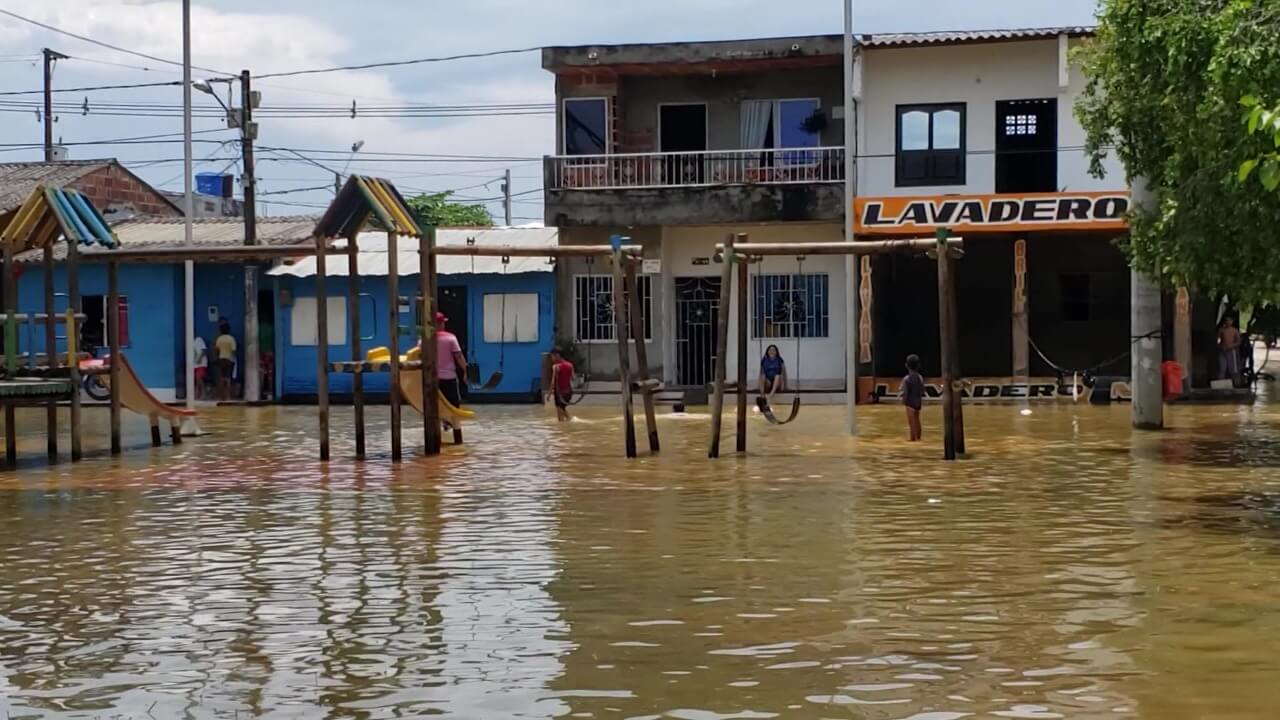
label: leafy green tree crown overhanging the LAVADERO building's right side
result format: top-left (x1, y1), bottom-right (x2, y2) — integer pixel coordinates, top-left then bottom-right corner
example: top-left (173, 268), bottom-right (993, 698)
top-left (1076, 0), bottom-right (1280, 305)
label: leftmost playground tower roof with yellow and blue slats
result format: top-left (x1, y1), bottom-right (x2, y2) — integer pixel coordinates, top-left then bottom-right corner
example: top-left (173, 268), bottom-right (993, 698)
top-left (0, 186), bottom-right (120, 252)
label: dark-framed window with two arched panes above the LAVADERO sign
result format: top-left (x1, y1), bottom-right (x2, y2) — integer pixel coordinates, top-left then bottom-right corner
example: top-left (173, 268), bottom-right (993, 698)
top-left (897, 104), bottom-right (965, 187)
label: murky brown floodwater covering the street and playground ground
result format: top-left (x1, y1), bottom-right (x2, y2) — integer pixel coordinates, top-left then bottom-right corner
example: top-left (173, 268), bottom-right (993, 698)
top-left (0, 394), bottom-right (1280, 720)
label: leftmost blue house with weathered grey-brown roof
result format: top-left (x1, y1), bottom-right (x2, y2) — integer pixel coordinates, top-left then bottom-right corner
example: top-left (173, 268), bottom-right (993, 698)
top-left (18, 218), bottom-right (315, 401)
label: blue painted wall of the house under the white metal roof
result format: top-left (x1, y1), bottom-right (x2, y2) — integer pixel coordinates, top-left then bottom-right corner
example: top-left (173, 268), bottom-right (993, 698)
top-left (276, 273), bottom-right (556, 400)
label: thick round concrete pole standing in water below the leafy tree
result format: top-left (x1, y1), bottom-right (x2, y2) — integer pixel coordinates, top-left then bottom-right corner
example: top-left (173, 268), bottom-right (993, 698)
top-left (1129, 178), bottom-right (1165, 430)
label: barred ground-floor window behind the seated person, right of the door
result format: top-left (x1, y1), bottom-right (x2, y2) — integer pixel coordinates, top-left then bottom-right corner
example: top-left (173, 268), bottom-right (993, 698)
top-left (751, 274), bottom-right (829, 338)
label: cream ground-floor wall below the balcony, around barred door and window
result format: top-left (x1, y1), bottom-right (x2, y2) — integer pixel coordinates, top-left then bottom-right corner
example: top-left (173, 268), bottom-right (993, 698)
top-left (662, 223), bottom-right (849, 389)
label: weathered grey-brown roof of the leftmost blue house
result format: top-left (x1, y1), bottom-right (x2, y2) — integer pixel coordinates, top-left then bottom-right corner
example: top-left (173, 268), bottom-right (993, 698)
top-left (17, 217), bottom-right (315, 263)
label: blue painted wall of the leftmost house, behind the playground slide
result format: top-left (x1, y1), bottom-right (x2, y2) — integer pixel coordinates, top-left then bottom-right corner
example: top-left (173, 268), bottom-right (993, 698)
top-left (18, 263), bottom-right (182, 388)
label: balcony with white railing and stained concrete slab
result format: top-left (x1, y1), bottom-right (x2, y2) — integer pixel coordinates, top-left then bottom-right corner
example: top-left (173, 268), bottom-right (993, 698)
top-left (544, 147), bottom-right (845, 227)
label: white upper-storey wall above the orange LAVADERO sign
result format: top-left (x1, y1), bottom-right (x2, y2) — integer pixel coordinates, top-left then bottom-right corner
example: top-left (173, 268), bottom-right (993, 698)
top-left (858, 38), bottom-right (1125, 196)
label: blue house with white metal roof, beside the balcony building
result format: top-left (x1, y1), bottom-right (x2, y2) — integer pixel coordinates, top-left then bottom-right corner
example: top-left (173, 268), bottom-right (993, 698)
top-left (264, 228), bottom-right (557, 401)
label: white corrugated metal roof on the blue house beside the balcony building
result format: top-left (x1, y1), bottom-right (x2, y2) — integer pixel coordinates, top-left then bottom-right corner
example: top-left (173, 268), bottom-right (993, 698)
top-left (268, 228), bottom-right (559, 278)
